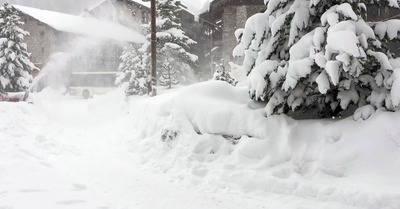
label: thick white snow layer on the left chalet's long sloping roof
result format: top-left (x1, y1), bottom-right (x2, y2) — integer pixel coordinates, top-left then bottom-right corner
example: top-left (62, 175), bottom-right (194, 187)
top-left (13, 5), bottom-right (145, 43)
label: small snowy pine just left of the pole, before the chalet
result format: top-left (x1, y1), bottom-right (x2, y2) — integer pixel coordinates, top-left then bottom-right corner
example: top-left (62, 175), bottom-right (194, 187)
top-left (115, 44), bottom-right (148, 96)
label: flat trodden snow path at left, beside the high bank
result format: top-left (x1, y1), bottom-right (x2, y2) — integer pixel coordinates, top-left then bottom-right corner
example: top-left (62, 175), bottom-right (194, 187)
top-left (0, 95), bottom-right (270, 209)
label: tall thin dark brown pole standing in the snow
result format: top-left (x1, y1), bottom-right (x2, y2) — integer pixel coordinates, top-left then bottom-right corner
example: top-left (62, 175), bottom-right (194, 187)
top-left (150, 0), bottom-right (157, 96)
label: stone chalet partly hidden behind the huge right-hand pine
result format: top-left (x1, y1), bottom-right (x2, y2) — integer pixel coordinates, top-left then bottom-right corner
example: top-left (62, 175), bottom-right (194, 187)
top-left (199, 0), bottom-right (266, 69)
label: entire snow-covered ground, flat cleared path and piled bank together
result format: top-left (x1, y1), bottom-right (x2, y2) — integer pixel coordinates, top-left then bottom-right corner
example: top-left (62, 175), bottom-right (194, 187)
top-left (0, 81), bottom-right (400, 209)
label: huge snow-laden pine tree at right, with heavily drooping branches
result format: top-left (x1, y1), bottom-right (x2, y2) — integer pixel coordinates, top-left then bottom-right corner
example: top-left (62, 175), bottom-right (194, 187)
top-left (234, 0), bottom-right (400, 118)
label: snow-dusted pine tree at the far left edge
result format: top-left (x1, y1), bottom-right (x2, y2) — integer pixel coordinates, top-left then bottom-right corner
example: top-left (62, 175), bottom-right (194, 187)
top-left (0, 2), bottom-right (38, 93)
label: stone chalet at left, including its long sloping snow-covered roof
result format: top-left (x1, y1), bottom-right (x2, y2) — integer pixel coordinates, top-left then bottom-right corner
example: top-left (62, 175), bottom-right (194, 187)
top-left (13, 5), bottom-right (145, 88)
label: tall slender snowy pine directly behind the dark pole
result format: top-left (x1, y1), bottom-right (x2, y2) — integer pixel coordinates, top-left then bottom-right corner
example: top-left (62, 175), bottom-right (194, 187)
top-left (141, 0), bottom-right (198, 88)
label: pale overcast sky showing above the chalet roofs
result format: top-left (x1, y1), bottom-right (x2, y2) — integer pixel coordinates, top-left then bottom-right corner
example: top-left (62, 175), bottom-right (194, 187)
top-left (0, 0), bottom-right (207, 14)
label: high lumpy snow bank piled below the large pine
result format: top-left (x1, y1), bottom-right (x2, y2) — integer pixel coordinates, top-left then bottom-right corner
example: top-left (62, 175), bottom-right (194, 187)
top-left (129, 81), bottom-right (400, 208)
